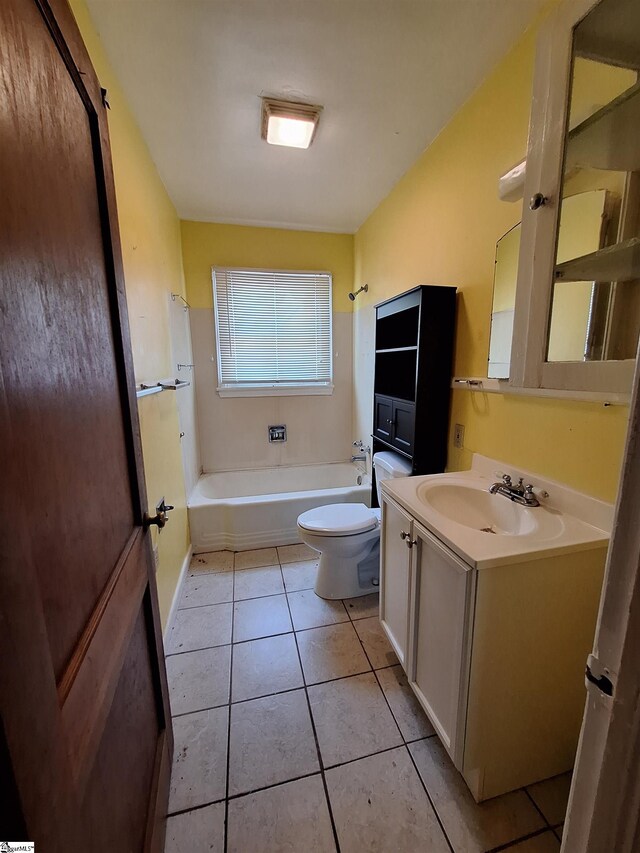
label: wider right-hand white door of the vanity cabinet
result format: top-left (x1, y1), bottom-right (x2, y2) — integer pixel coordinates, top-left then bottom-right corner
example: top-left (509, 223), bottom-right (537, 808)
top-left (407, 522), bottom-right (476, 769)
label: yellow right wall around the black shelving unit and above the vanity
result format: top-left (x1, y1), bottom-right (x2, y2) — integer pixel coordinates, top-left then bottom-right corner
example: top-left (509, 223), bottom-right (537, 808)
top-left (354, 10), bottom-right (628, 500)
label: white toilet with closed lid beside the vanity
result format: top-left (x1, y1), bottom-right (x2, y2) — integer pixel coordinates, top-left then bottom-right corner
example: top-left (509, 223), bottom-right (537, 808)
top-left (298, 450), bottom-right (411, 599)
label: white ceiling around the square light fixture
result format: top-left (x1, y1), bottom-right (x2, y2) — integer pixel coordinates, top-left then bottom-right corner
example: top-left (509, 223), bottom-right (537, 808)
top-left (88, 0), bottom-right (543, 232)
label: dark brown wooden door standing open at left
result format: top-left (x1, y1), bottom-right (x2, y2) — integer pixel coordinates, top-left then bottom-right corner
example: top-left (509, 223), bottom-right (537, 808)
top-left (0, 0), bottom-right (172, 853)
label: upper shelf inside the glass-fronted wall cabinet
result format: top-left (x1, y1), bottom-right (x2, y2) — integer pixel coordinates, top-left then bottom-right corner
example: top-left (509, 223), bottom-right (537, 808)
top-left (565, 82), bottom-right (640, 172)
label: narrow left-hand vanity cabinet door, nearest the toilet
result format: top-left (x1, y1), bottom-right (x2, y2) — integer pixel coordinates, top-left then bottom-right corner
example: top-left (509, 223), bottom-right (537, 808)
top-left (380, 497), bottom-right (415, 669)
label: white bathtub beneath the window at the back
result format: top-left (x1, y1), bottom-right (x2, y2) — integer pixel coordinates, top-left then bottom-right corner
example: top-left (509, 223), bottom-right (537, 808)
top-left (187, 462), bottom-right (371, 554)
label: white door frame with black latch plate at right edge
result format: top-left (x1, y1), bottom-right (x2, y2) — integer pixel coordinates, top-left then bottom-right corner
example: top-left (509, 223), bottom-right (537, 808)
top-left (562, 358), bottom-right (640, 853)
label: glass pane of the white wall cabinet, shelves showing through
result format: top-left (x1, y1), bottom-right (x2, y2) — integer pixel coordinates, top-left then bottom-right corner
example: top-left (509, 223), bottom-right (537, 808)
top-left (547, 0), bottom-right (640, 362)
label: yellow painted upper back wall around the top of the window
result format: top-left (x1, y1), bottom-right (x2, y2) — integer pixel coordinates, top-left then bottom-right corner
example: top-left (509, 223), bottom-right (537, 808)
top-left (182, 221), bottom-right (353, 312)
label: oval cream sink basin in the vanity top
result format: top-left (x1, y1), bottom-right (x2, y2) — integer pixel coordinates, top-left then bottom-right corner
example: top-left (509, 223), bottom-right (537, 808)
top-left (417, 483), bottom-right (562, 539)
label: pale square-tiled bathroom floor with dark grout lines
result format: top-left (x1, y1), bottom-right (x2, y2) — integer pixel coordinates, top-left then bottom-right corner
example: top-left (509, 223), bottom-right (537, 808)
top-left (165, 545), bottom-right (569, 853)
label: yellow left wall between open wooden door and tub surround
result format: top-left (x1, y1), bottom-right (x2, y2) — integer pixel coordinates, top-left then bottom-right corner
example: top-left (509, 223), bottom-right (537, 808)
top-left (71, 0), bottom-right (189, 624)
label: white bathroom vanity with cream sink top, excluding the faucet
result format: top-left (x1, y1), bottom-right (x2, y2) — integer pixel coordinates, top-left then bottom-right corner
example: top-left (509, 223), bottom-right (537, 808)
top-left (380, 454), bottom-right (612, 801)
